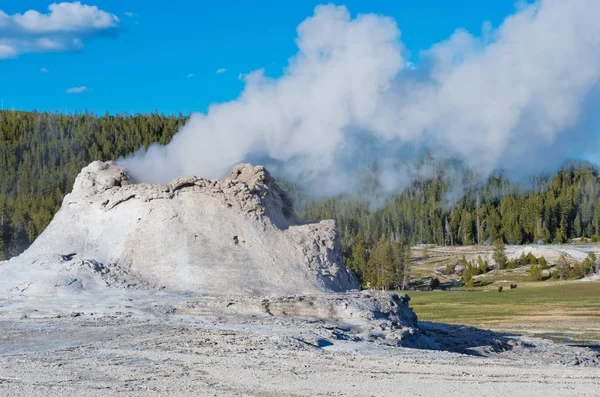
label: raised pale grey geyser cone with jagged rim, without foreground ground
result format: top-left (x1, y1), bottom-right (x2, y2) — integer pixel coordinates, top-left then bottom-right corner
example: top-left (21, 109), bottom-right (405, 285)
top-left (0, 161), bottom-right (358, 296)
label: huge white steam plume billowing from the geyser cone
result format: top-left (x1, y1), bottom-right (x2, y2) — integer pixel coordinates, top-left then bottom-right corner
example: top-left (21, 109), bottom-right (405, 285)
top-left (121, 0), bottom-right (600, 193)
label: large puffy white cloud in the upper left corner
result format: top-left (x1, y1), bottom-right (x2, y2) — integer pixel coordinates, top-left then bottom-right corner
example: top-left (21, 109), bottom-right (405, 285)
top-left (0, 1), bottom-right (119, 59)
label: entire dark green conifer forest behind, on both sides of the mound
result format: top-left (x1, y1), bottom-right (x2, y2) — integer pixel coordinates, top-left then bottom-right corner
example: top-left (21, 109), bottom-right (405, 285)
top-left (0, 111), bottom-right (600, 287)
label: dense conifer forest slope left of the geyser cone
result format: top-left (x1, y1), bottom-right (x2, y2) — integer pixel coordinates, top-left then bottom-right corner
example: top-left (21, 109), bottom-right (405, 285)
top-left (0, 111), bottom-right (187, 260)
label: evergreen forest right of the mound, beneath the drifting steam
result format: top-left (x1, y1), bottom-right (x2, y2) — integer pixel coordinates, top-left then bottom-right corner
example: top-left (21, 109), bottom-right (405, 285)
top-left (294, 162), bottom-right (600, 286)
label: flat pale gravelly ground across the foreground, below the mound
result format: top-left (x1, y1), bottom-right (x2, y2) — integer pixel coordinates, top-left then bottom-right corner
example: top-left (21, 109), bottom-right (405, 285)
top-left (0, 309), bottom-right (600, 397)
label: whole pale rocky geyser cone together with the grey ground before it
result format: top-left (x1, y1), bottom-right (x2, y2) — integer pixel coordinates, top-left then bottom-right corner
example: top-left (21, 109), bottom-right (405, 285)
top-left (0, 162), bottom-right (600, 397)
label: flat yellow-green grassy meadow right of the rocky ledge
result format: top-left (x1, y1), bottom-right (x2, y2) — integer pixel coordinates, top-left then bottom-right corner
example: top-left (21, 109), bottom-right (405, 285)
top-left (408, 281), bottom-right (600, 341)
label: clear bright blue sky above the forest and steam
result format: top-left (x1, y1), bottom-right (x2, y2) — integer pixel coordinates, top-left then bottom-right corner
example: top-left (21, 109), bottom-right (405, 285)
top-left (0, 0), bottom-right (515, 114)
